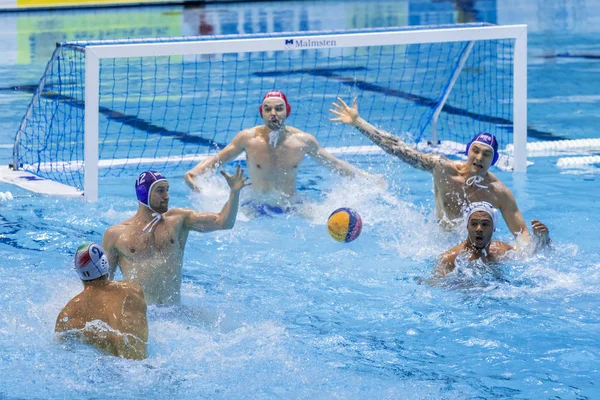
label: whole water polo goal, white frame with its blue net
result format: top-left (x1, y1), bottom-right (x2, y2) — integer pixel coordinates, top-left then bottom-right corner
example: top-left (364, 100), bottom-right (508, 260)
top-left (13, 24), bottom-right (527, 201)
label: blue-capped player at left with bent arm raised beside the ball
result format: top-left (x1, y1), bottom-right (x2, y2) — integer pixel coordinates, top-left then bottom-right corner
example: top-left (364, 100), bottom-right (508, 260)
top-left (102, 166), bottom-right (249, 304)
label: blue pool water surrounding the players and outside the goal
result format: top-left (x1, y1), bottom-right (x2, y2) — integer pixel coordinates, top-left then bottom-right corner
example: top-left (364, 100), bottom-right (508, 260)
top-left (0, 1), bottom-right (600, 399)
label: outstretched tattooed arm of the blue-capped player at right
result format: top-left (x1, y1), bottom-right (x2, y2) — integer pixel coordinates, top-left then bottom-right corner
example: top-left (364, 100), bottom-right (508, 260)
top-left (329, 97), bottom-right (445, 172)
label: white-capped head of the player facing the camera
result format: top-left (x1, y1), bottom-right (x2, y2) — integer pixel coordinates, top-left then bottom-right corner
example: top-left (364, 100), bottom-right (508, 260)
top-left (465, 201), bottom-right (498, 249)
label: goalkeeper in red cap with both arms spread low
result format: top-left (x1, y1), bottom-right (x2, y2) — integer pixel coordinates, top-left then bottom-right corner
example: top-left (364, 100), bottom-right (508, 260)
top-left (185, 90), bottom-right (368, 208)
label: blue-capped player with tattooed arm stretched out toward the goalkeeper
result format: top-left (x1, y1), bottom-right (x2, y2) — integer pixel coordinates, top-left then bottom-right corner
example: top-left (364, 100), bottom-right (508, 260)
top-left (330, 98), bottom-right (530, 245)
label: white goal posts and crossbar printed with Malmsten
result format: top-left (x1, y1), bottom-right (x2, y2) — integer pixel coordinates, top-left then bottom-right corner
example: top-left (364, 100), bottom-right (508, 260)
top-left (83, 25), bottom-right (527, 202)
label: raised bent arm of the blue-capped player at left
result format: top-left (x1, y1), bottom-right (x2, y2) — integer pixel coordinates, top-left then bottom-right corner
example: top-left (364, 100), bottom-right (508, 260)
top-left (183, 165), bottom-right (250, 232)
